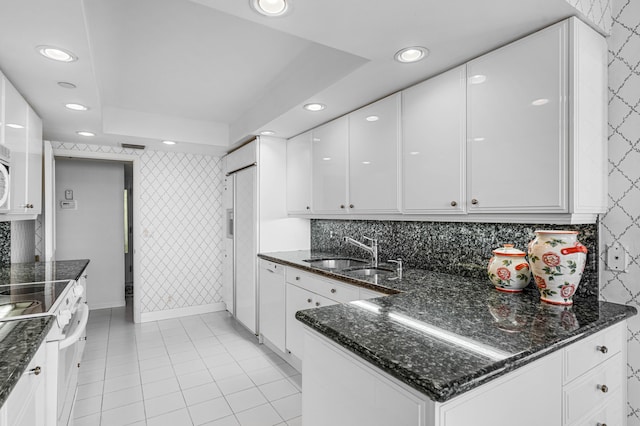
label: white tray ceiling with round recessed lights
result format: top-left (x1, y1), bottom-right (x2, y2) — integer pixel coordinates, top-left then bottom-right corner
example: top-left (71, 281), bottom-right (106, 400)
top-left (0, 0), bottom-right (576, 153)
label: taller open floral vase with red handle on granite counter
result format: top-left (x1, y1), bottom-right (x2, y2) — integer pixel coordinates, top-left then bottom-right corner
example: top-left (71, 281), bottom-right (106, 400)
top-left (529, 231), bottom-right (587, 305)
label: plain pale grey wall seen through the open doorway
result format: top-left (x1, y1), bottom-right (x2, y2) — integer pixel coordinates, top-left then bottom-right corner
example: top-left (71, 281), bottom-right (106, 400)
top-left (55, 158), bottom-right (125, 309)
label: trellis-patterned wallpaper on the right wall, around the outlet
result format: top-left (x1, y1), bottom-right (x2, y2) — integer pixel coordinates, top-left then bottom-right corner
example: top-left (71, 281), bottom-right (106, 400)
top-left (600, 0), bottom-right (640, 426)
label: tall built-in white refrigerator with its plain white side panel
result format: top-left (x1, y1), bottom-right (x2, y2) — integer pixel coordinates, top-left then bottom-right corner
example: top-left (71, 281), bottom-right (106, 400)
top-left (223, 136), bottom-right (309, 335)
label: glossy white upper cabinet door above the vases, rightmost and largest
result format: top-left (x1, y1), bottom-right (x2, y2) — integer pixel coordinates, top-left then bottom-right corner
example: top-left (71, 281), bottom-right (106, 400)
top-left (467, 22), bottom-right (567, 213)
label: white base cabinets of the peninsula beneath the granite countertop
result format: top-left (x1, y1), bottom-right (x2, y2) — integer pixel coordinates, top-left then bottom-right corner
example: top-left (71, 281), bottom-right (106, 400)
top-left (302, 322), bottom-right (626, 426)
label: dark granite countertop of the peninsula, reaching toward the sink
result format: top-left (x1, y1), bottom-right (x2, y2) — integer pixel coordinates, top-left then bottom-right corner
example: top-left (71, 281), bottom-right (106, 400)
top-left (259, 250), bottom-right (637, 402)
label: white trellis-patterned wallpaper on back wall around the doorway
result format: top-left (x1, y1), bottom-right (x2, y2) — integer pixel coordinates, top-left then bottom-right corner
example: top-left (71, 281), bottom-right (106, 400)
top-left (52, 142), bottom-right (223, 313)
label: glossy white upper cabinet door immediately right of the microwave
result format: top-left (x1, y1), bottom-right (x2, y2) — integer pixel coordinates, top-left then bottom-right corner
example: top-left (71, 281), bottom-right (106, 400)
top-left (5, 79), bottom-right (28, 213)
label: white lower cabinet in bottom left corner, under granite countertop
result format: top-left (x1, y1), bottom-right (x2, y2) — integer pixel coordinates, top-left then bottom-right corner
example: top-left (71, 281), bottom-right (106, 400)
top-left (0, 342), bottom-right (47, 426)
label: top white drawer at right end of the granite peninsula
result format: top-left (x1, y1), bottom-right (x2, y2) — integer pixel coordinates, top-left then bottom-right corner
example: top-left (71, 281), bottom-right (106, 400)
top-left (564, 323), bottom-right (626, 383)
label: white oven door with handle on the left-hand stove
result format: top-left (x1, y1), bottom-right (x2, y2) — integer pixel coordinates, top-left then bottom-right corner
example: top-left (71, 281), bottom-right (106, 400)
top-left (57, 303), bottom-right (89, 426)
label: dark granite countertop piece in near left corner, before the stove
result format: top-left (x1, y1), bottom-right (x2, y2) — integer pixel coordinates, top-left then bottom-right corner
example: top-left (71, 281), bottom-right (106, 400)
top-left (0, 315), bottom-right (54, 408)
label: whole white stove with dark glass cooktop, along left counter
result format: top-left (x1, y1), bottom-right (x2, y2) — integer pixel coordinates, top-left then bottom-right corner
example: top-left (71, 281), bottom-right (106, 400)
top-left (0, 276), bottom-right (89, 426)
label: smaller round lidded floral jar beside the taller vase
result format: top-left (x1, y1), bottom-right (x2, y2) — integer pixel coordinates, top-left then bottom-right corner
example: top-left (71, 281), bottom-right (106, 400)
top-left (487, 244), bottom-right (531, 293)
